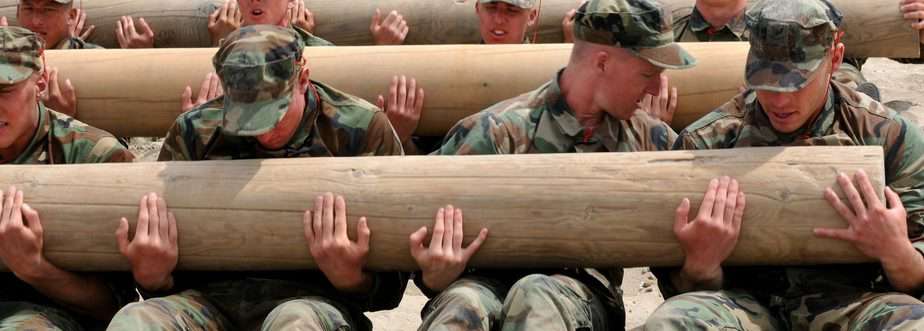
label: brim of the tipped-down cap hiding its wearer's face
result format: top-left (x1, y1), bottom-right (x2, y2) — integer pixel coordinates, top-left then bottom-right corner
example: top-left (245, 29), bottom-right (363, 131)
top-left (222, 94), bottom-right (292, 137)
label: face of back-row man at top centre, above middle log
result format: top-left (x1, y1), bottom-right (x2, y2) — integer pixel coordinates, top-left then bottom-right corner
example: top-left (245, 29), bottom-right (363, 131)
top-left (475, 2), bottom-right (538, 44)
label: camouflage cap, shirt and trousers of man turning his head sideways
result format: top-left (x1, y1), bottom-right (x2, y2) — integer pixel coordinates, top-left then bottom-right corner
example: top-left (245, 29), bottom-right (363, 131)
top-left (424, 0), bottom-right (695, 330)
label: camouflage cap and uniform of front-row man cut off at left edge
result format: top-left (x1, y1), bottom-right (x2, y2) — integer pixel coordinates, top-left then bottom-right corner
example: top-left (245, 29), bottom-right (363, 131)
top-left (0, 27), bottom-right (133, 330)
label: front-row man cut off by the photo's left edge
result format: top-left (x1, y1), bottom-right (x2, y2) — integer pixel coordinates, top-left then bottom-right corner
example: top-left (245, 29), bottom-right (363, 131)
top-left (0, 27), bottom-right (139, 330)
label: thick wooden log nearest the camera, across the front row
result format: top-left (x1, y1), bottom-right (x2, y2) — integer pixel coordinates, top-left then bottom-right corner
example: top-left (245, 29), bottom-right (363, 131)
top-left (0, 147), bottom-right (885, 270)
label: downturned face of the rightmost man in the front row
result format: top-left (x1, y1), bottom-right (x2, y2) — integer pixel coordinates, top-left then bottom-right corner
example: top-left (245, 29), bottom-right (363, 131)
top-left (757, 45), bottom-right (843, 133)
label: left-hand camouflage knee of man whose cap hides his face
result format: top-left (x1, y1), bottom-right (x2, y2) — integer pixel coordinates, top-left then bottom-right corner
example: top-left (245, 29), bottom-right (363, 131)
top-left (107, 290), bottom-right (233, 331)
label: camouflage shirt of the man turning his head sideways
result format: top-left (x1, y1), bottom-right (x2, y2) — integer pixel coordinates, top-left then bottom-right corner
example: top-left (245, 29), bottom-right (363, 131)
top-left (434, 72), bottom-right (677, 155)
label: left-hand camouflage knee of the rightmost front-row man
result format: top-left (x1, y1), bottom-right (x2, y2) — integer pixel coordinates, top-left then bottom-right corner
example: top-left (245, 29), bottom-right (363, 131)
top-left (645, 291), bottom-right (782, 331)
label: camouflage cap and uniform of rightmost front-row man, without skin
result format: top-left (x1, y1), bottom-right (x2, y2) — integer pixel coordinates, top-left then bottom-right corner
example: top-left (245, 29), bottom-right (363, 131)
top-left (646, 0), bottom-right (924, 330)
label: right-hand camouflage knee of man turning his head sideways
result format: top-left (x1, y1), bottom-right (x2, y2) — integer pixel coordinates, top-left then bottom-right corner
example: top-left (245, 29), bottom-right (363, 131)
top-left (501, 274), bottom-right (609, 331)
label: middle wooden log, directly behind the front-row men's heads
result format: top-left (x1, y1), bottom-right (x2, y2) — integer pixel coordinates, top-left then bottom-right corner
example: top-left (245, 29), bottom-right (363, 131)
top-left (46, 43), bottom-right (748, 136)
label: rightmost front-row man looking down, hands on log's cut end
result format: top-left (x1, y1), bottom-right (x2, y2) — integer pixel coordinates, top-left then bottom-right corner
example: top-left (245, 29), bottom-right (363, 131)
top-left (646, 0), bottom-right (924, 330)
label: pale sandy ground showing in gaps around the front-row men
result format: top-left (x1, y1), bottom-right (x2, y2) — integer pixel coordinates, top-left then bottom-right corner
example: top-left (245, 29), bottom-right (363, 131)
top-left (131, 59), bottom-right (924, 331)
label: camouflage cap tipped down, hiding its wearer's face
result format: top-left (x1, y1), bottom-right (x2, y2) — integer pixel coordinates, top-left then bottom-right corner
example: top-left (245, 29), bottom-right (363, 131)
top-left (212, 25), bottom-right (304, 136)
